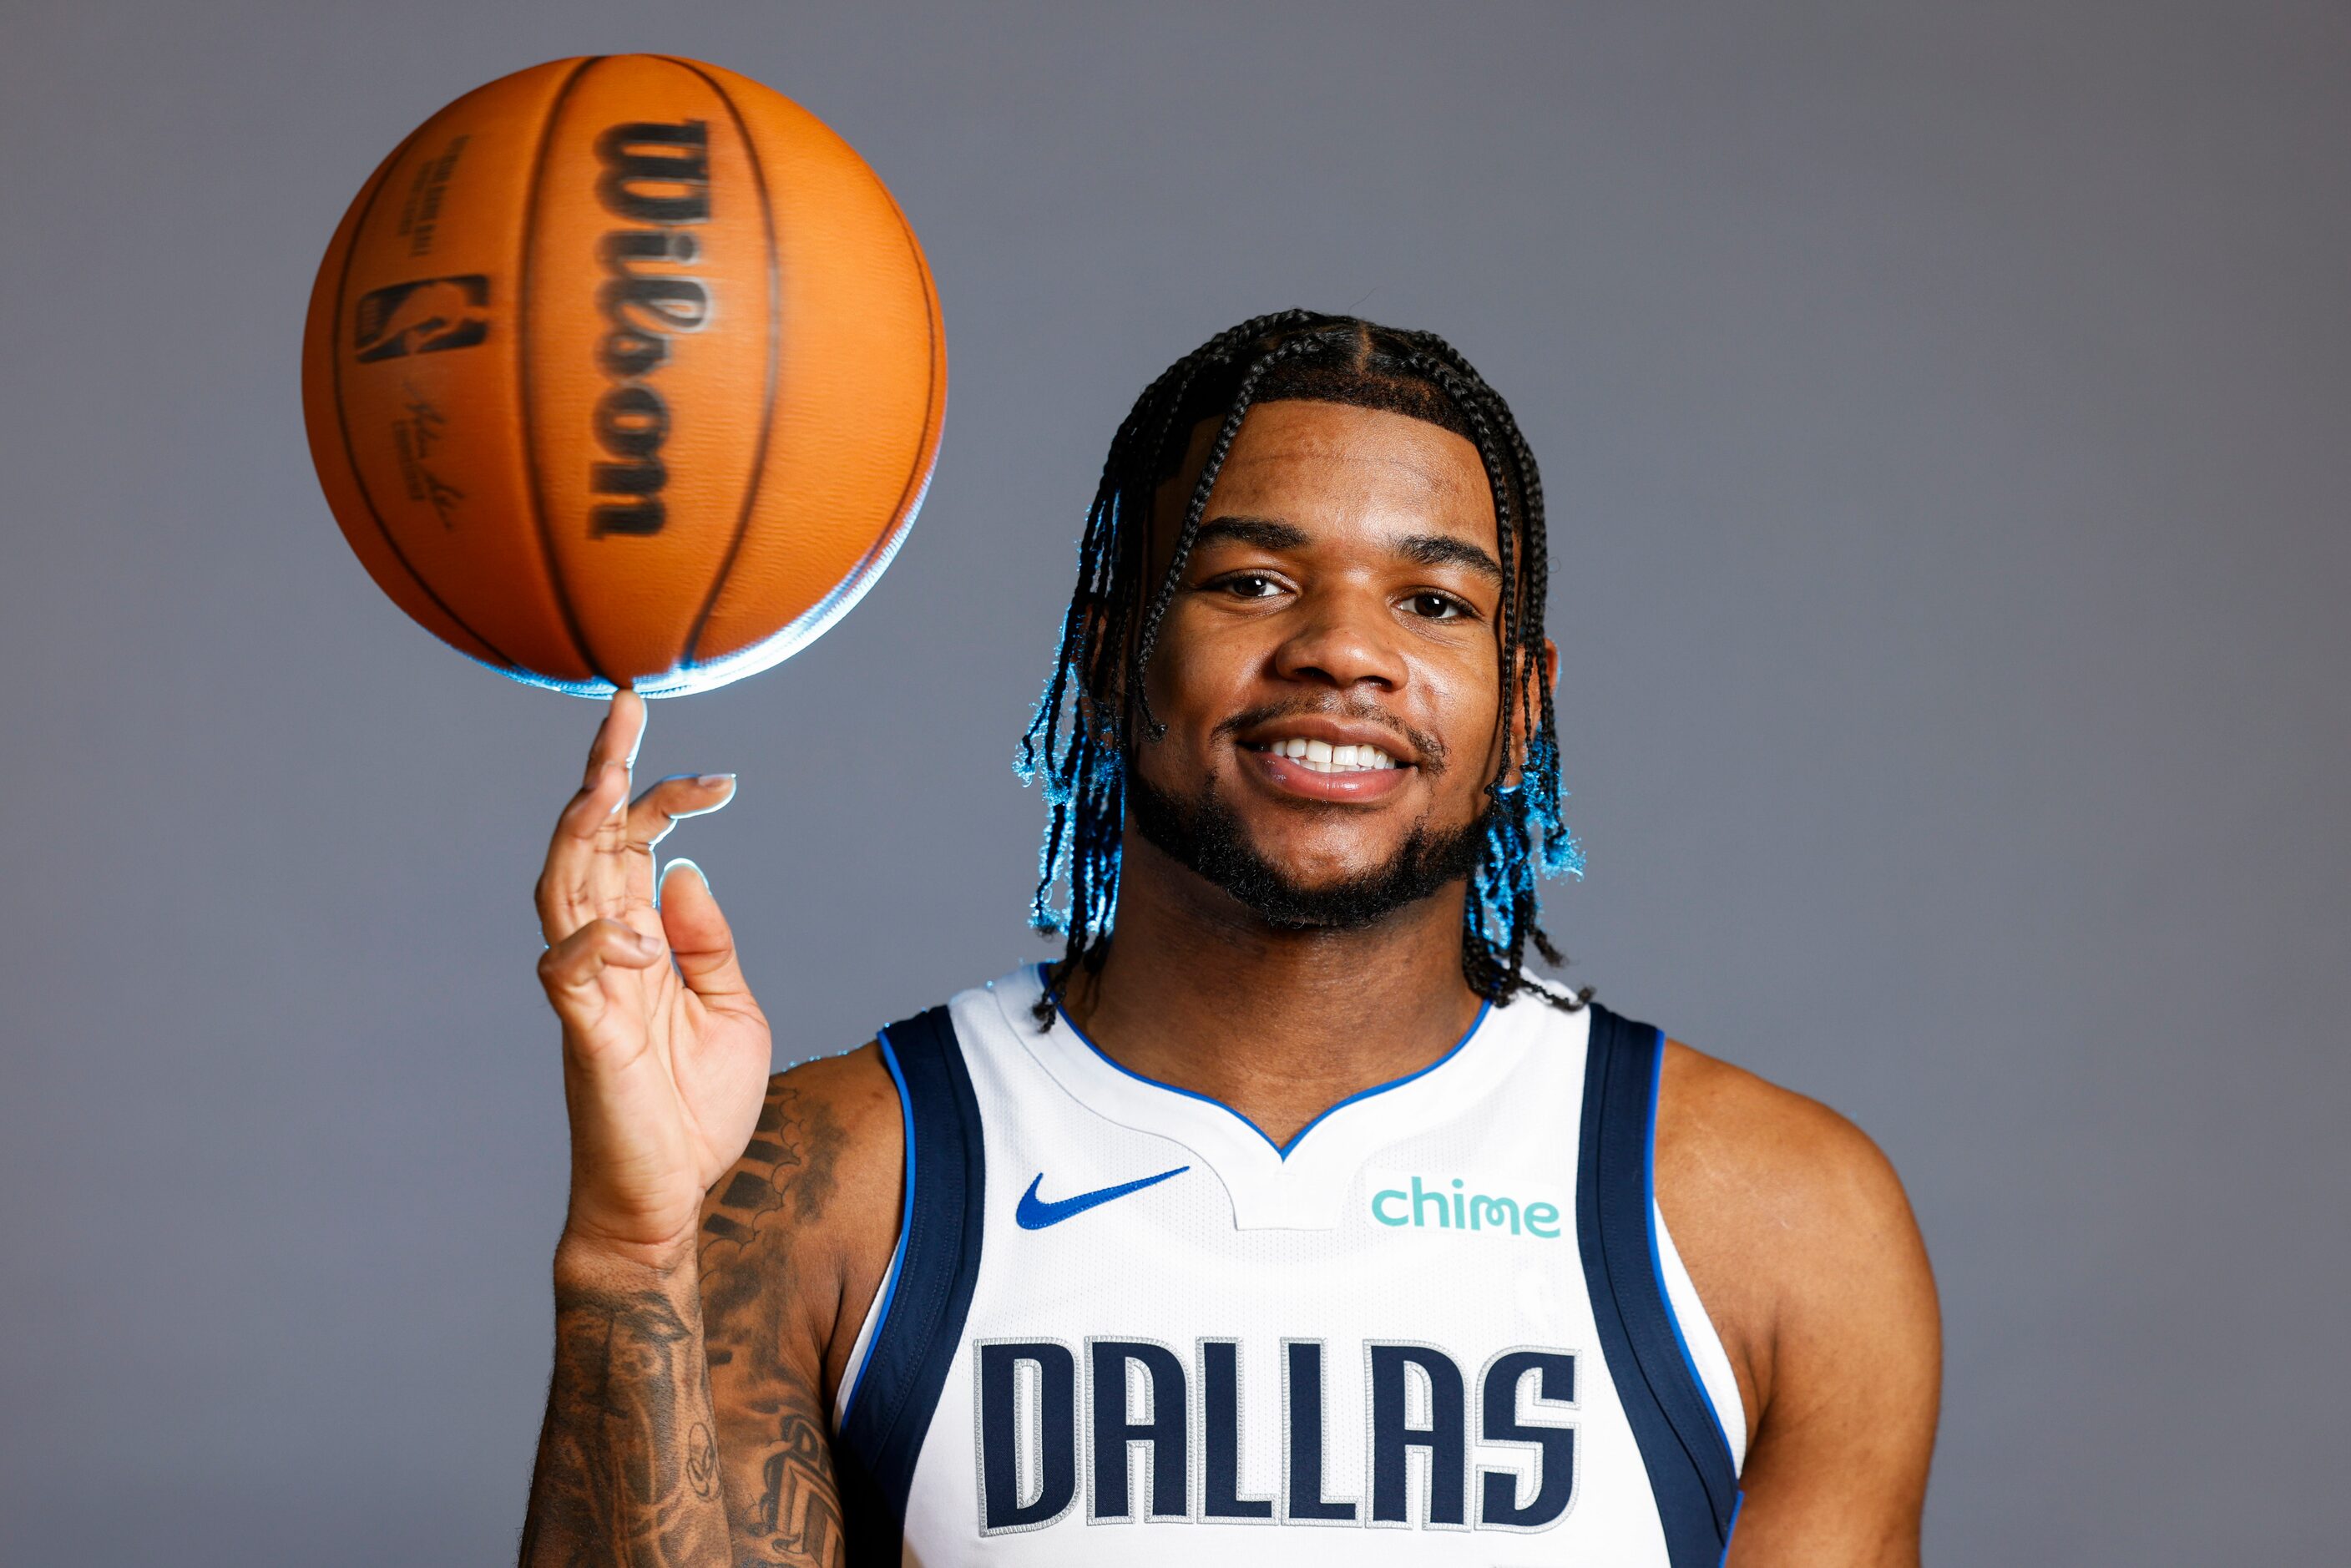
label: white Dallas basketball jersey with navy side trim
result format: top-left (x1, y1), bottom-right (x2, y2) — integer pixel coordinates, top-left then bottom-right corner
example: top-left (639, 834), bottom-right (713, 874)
top-left (835, 966), bottom-right (1744, 1568)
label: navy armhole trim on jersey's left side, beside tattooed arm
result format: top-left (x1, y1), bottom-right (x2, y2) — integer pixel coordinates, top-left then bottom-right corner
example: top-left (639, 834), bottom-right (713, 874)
top-left (832, 1006), bottom-right (988, 1568)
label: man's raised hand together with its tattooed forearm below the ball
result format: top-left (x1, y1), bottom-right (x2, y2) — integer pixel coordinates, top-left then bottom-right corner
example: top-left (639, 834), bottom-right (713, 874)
top-left (522, 691), bottom-right (813, 1568)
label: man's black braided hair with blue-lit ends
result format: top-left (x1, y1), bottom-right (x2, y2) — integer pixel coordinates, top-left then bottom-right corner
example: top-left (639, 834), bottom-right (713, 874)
top-left (1016, 311), bottom-right (1591, 1025)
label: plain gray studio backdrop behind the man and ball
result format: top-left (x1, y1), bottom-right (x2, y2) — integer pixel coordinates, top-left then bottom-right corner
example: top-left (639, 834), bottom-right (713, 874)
top-left (0, 0), bottom-right (2351, 1565)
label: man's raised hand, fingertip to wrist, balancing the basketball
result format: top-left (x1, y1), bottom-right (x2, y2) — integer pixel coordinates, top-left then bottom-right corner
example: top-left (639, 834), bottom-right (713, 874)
top-left (538, 691), bottom-right (771, 1267)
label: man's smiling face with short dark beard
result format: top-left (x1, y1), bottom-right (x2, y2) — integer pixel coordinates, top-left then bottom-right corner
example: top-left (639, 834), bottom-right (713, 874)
top-left (1133, 400), bottom-right (1550, 926)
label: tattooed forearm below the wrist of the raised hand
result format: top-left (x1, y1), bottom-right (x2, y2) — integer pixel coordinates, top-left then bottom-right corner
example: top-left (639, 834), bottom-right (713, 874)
top-left (522, 1243), bottom-right (731, 1568)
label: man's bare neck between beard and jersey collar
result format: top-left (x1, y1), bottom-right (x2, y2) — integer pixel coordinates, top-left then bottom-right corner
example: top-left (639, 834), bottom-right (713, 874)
top-left (1065, 832), bottom-right (1479, 1145)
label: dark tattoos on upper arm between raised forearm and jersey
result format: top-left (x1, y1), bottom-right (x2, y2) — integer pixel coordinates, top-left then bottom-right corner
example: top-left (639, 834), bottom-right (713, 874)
top-left (700, 1077), bottom-right (847, 1568)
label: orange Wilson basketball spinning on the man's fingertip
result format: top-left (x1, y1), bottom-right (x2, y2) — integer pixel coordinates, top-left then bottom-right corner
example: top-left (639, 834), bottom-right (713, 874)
top-left (303, 54), bottom-right (948, 695)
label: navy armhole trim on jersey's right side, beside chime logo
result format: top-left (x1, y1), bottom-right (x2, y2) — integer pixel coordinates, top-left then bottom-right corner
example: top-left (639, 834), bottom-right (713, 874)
top-left (1575, 1004), bottom-right (1740, 1568)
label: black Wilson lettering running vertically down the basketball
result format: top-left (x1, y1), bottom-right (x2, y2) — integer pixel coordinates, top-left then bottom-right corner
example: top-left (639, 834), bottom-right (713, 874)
top-left (588, 120), bottom-right (712, 539)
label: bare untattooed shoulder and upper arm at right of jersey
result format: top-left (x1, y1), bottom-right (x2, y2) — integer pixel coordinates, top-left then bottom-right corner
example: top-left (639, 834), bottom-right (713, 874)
top-left (1657, 1041), bottom-right (1942, 1563)
